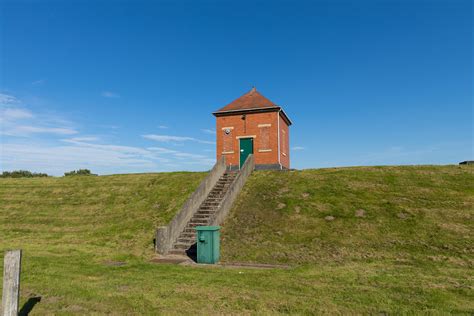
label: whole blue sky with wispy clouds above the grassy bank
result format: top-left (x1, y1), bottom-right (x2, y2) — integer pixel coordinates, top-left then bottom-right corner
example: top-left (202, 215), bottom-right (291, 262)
top-left (0, 0), bottom-right (474, 175)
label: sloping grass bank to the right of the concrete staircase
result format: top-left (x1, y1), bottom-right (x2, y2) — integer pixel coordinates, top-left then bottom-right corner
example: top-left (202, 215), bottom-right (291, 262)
top-left (223, 166), bottom-right (474, 265)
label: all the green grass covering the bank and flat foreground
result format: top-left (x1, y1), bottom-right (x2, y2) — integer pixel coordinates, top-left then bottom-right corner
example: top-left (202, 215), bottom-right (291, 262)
top-left (0, 166), bottom-right (474, 315)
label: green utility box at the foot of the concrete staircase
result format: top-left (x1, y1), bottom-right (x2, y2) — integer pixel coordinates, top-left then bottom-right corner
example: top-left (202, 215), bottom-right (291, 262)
top-left (196, 226), bottom-right (221, 264)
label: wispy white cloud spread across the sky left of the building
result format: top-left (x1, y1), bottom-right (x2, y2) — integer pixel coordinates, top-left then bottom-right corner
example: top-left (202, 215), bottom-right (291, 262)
top-left (0, 94), bottom-right (215, 175)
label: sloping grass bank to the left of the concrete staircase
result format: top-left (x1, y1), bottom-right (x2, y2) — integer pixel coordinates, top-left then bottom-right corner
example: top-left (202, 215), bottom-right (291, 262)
top-left (0, 172), bottom-right (205, 258)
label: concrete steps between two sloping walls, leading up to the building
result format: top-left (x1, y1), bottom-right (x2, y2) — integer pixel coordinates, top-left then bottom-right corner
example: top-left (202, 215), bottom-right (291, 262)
top-left (169, 171), bottom-right (238, 255)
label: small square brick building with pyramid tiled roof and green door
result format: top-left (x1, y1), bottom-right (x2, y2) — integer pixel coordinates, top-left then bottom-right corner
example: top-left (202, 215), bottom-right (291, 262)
top-left (212, 88), bottom-right (292, 169)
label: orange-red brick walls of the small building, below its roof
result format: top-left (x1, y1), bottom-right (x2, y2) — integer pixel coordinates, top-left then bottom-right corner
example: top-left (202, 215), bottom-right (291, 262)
top-left (216, 112), bottom-right (289, 167)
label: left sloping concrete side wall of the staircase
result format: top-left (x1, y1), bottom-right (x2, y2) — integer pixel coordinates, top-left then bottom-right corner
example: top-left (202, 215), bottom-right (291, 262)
top-left (155, 156), bottom-right (227, 255)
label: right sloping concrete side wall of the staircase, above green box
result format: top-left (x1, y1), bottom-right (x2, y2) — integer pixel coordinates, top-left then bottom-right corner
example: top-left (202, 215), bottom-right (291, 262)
top-left (211, 154), bottom-right (255, 226)
